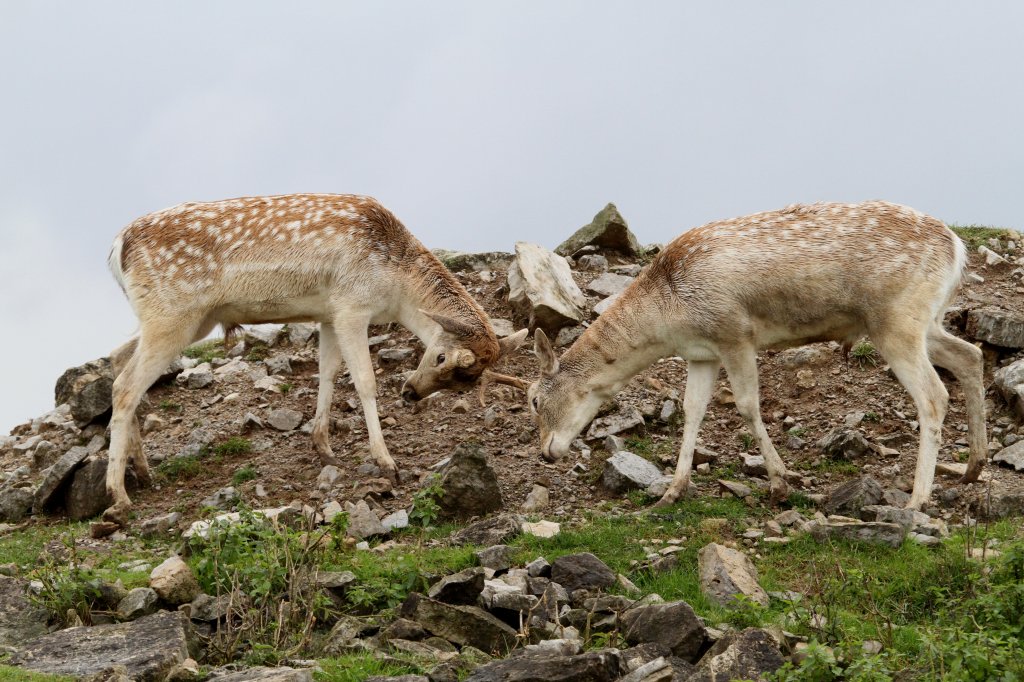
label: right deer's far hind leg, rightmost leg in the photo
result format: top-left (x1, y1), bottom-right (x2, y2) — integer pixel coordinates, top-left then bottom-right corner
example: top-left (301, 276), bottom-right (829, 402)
top-left (928, 324), bottom-right (988, 483)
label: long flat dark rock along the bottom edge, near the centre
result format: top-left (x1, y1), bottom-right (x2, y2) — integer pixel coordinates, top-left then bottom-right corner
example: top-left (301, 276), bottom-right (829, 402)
top-left (466, 649), bottom-right (626, 682)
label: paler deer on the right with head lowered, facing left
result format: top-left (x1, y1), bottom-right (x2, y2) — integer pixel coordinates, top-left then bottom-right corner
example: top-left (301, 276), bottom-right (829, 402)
top-left (527, 201), bottom-right (987, 510)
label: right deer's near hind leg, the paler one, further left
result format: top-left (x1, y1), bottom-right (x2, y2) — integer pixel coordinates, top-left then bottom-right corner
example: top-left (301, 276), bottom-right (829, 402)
top-left (872, 329), bottom-right (949, 510)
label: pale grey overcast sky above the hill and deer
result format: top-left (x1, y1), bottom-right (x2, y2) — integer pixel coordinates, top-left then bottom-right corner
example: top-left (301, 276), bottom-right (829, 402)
top-left (0, 0), bottom-right (1024, 433)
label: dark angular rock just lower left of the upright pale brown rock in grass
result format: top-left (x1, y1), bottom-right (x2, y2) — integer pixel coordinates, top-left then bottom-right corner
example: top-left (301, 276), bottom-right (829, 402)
top-left (618, 601), bottom-right (708, 663)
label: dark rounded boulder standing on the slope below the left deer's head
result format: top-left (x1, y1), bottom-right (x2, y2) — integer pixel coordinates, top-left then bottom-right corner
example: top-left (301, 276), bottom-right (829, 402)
top-left (437, 442), bottom-right (505, 519)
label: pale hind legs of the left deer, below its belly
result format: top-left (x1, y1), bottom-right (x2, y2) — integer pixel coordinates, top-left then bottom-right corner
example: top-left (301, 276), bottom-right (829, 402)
top-left (103, 319), bottom-right (206, 525)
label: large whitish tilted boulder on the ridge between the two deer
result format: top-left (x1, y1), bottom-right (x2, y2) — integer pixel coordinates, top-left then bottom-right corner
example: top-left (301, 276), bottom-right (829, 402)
top-left (508, 242), bottom-right (587, 336)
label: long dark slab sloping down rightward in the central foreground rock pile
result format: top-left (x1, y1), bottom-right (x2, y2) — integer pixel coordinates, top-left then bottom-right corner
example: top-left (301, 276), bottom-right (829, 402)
top-left (399, 593), bottom-right (516, 655)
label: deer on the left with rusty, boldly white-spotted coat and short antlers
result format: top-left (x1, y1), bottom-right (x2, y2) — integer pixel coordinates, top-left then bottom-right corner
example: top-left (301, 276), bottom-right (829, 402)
top-left (103, 194), bottom-right (528, 525)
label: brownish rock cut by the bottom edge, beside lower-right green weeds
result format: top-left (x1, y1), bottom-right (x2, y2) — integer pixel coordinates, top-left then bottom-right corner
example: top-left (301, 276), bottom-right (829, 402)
top-left (688, 628), bottom-right (785, 682)
